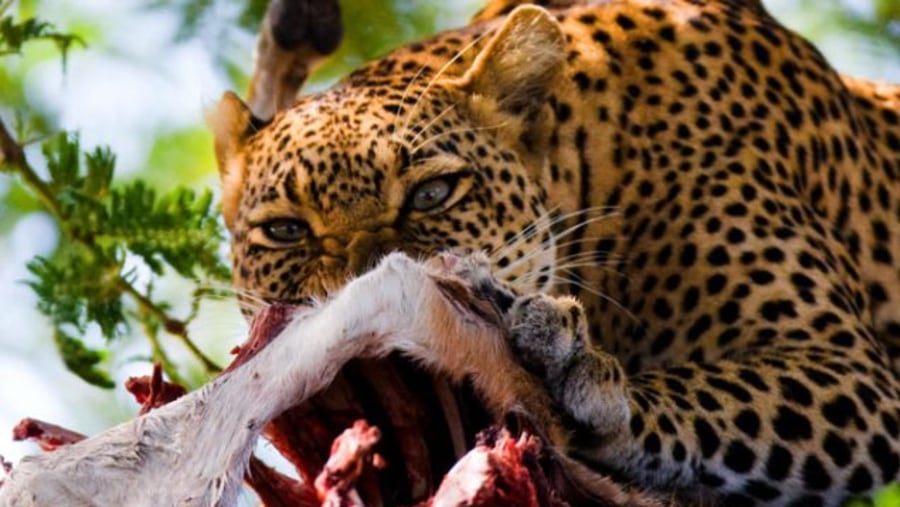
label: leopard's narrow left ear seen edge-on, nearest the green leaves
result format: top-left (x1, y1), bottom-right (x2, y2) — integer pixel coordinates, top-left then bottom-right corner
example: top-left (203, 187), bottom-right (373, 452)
top-left (206, 92), bottom-right (264, 229)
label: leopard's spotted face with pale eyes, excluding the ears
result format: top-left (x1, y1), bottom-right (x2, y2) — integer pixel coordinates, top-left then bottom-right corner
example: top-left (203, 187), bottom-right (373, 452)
top-left (221, 86), bottom-right (553, 306)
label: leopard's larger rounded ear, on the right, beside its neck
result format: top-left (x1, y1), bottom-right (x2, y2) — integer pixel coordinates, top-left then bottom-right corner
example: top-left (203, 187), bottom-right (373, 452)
top-left (460, 5), bottom-right (565, 114)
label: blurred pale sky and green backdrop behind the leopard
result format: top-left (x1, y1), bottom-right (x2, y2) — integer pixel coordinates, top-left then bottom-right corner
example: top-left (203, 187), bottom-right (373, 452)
top-left (0, 0), bottom-right (900, 504)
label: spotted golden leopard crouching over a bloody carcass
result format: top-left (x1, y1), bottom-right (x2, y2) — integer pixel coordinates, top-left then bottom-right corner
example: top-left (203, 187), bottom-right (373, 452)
top-left (210, 0), bottom-right (900, 506)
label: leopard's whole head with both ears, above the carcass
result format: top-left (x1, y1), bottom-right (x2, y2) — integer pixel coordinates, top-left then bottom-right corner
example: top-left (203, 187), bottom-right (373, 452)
top-left (211, 7), bottom-right (565, 301)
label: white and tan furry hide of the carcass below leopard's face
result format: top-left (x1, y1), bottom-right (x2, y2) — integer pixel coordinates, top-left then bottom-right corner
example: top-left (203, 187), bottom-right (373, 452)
top-left (0, 254), bottom-right (655, 506)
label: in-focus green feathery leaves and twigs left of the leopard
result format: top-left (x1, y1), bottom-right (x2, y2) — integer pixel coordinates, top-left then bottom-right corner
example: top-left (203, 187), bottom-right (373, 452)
top-left (0, 3), bottom-right (229, 387)
